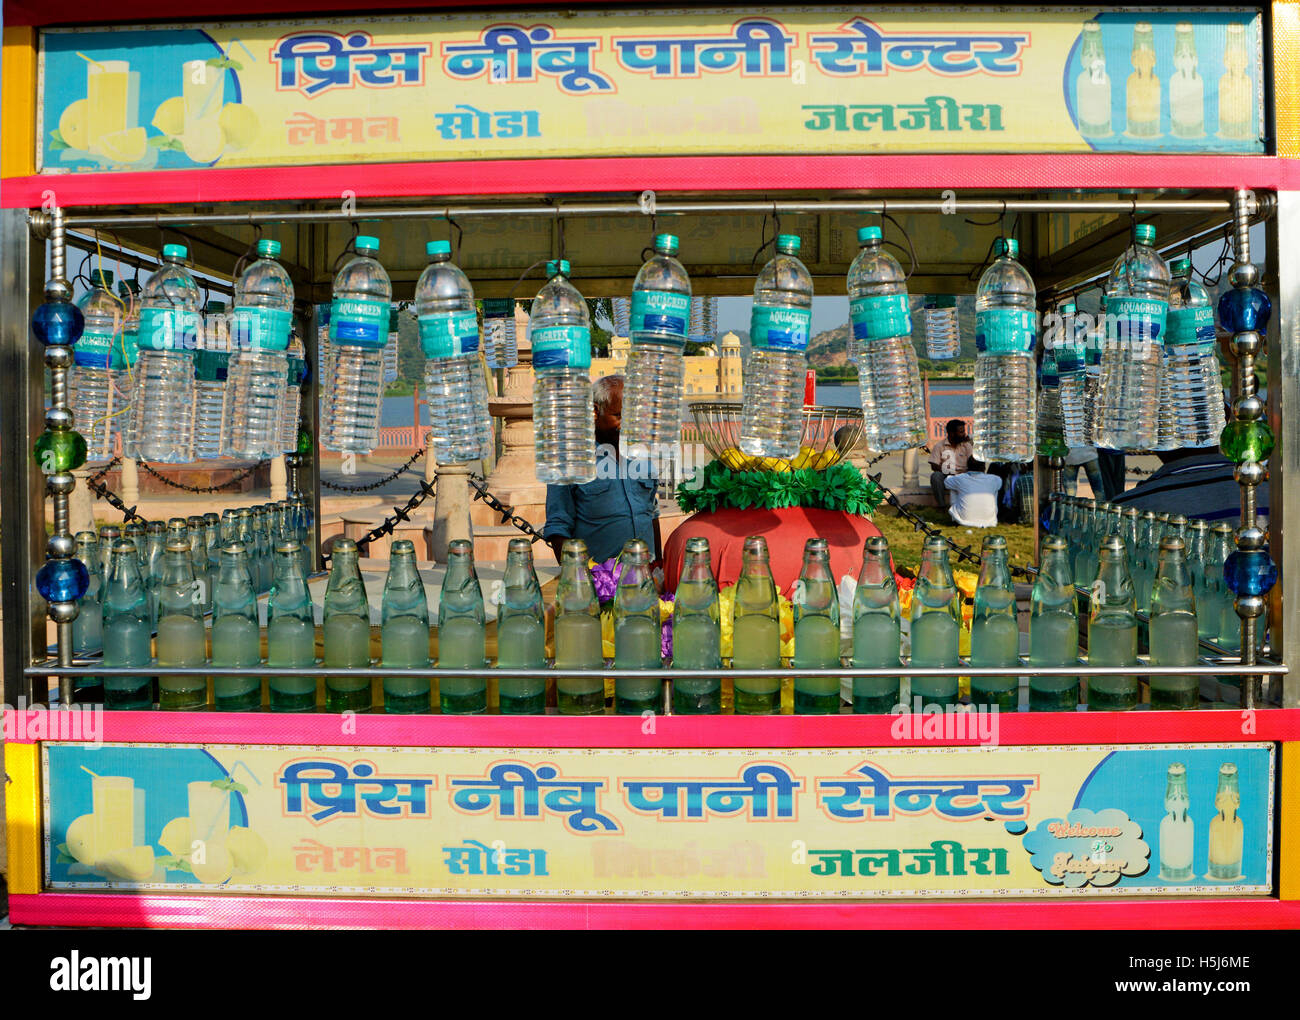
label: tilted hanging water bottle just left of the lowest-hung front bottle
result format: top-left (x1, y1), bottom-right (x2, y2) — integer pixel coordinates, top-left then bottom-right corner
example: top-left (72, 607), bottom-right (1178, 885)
top-left (415, 240), bottom-right (491, 464)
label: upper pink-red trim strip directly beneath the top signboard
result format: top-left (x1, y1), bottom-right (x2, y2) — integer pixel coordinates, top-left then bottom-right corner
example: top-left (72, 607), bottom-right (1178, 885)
top-left (0, 153), bottom-right (1300, 209)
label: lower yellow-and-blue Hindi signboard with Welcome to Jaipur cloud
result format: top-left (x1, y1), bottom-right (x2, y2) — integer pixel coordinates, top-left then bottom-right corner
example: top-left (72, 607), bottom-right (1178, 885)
top-left (42, 743), bottom-right (1274, 898)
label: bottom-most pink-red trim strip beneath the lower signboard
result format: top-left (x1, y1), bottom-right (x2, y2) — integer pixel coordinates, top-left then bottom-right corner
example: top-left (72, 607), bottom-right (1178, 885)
top-left (9, 893), bottom-right (1300, 930)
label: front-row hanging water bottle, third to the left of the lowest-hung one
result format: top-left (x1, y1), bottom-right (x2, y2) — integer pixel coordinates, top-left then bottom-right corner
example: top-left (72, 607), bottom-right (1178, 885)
top-left (226, 239), bottom-right (294, 460)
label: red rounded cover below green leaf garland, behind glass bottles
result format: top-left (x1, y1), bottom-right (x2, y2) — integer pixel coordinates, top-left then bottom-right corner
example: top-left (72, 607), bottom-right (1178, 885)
top-left (663, 507), bottom-right (880, 596)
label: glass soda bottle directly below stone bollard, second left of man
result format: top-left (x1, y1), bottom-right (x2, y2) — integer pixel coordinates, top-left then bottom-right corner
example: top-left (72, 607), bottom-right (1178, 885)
top-left (438, 538), bottom-right (488, 715)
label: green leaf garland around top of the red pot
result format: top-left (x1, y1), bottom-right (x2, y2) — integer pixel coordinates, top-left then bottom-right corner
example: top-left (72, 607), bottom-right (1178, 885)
top-left (677, 460), bottom-right (884, 517)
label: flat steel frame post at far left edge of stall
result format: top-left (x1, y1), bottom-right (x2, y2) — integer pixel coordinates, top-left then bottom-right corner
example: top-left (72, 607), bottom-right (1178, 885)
top-left (0, 209), bottom-right (46, 706)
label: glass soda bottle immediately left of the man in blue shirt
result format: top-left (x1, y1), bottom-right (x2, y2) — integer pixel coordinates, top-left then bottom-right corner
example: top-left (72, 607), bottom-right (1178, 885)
top-left (497, 538), bottom-right (546, 716)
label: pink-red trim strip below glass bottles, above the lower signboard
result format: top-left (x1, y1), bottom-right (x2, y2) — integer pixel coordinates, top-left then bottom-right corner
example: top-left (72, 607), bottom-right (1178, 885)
top-left (5, 708), bottom-right (1300, 748)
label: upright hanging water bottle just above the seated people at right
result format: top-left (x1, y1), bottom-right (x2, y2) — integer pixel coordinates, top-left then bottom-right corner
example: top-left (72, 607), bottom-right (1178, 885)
top-left (974, 238), bottom-right (1037, 464)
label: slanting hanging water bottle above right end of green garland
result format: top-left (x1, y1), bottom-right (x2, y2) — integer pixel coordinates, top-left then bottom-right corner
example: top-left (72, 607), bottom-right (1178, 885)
top-left (848, 226), bottom-right (926, 453)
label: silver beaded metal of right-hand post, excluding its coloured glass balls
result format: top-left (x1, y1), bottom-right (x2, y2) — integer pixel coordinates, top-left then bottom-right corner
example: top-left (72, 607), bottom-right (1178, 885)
top-left (1230, 188), bottom-right (1266, 708)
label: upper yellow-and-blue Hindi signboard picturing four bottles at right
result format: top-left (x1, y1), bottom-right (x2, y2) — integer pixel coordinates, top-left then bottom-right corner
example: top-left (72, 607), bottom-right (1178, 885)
top-left (39, 8), bottom-right (1264, 171)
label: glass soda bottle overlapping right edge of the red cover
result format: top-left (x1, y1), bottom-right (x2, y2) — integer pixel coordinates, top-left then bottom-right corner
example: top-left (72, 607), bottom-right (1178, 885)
top-left (853, 535), bottom-right (902, 713)
